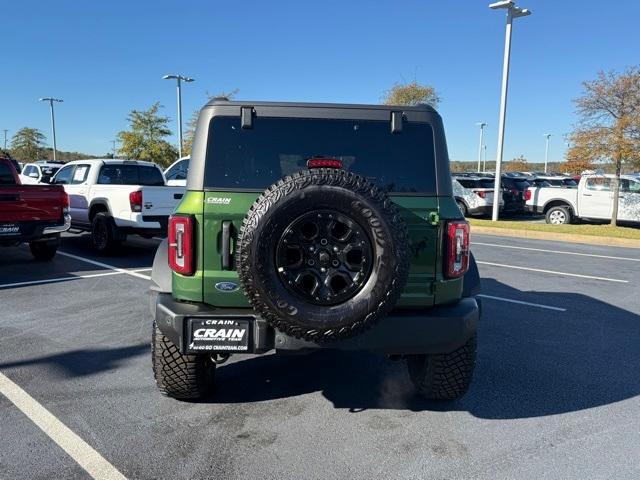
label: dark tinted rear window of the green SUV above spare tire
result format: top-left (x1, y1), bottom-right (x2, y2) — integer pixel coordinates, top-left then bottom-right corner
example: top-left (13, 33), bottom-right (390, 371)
top-left (204, 117), bottom-right (435, 193)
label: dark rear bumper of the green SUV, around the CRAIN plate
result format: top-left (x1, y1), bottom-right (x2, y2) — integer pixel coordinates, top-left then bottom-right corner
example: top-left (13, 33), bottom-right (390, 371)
top-left (150, 293), bottom-right (480, 355)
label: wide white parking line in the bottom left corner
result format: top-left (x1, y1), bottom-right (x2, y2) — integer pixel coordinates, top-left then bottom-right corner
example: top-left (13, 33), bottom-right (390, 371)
top-left (0, 373), bottom-right (126, 480)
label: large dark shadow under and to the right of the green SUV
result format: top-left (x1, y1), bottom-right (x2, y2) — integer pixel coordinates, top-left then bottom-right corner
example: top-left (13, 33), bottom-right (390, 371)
top-left (207, 279), bottom-right (640, 419)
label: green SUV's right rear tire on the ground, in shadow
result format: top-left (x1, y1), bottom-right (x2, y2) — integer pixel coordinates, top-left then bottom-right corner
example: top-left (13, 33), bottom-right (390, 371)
top-left (407, 334), bottom-right (476, 400)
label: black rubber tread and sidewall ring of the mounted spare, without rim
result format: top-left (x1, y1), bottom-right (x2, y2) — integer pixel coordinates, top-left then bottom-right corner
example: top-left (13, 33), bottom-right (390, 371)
top-left (236, 168), bottom-right (409, 343)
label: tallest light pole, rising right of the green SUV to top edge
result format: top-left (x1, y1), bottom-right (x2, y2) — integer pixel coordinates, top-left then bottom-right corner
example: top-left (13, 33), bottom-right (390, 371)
top-left (489, 0), bottom-right (531, 222)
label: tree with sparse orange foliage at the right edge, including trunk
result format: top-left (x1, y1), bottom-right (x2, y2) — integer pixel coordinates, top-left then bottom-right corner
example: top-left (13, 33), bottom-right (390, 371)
top-left (567, 67), bottom-right (640, 226)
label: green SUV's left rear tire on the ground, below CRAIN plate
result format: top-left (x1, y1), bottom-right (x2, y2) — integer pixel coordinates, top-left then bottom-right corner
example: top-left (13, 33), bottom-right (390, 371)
top-left (151, 321), bottom-right (216, 400)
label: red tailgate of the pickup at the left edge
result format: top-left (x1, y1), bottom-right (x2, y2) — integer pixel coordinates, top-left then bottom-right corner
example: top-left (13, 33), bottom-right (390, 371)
top-left (0, 185), bottom-right (65, 223)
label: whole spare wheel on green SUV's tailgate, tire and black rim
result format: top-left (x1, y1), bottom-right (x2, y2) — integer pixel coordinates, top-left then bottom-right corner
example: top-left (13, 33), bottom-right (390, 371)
top-left (236, 168), bottom-right (409, 343)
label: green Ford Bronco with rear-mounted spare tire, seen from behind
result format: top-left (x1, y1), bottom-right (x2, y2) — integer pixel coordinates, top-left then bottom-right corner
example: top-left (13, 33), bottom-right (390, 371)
top-left (151, 99), bottom-right (480, 400)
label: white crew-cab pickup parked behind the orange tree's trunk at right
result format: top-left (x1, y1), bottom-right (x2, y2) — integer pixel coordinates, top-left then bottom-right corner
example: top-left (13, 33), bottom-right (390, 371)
top-left (526, 175), bottom-right (640, 225)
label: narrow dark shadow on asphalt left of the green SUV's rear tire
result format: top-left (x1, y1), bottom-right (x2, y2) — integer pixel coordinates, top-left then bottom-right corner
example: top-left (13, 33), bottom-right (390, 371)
top-left (0, 343), bottom-right (150, 378)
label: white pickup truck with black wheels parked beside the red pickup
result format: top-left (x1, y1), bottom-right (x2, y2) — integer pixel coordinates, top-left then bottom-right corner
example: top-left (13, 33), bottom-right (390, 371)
top-left (51, 160), bottom-right (185, 253)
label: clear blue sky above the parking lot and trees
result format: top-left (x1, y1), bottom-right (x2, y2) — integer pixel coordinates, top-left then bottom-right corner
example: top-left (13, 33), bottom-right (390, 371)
top-left (0, 0), bottom-right (640, 165)
